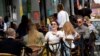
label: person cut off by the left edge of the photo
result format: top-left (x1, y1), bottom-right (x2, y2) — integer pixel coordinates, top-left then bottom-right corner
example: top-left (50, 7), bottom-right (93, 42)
top-left (0, 16), bottom-right (7, 37)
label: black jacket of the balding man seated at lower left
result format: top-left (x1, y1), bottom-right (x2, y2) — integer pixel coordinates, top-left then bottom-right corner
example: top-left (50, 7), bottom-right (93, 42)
top-left (0, 38), bottom-right (24, 56)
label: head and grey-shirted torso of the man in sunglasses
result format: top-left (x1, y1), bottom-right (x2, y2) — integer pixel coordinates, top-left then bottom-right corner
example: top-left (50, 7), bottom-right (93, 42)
top-left (76, 16), bottom-right (89, 39)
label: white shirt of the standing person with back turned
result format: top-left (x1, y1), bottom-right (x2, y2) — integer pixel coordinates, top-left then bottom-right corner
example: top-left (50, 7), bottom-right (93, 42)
top-left (57, 10), bottom-right (69, 28)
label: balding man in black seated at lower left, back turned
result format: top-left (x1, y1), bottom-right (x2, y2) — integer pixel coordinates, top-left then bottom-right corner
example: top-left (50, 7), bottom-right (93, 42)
top-left (0, 28), bottom-right (31, 56)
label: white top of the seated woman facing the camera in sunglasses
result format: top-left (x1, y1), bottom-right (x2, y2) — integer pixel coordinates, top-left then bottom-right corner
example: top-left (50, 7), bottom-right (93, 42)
top-left (45, 31), bottom-right (62, 56)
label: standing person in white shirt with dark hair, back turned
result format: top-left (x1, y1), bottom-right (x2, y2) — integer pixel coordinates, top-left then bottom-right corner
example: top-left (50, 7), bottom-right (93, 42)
top-left (57, 4), bottom-right (70, 28)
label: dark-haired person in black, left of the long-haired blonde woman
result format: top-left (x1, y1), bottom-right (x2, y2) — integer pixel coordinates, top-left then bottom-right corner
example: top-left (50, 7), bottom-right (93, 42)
top-left (16, 15), bottom-right (29, 39)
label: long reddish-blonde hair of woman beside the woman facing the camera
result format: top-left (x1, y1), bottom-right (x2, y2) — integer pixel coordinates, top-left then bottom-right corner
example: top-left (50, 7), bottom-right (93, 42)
top-left (63, 22), bottom-right (75, 35)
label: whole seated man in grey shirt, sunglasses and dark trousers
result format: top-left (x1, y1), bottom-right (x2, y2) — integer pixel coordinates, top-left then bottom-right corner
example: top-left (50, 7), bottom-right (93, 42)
top-left (75, 16), bottom-right (90, 56)
